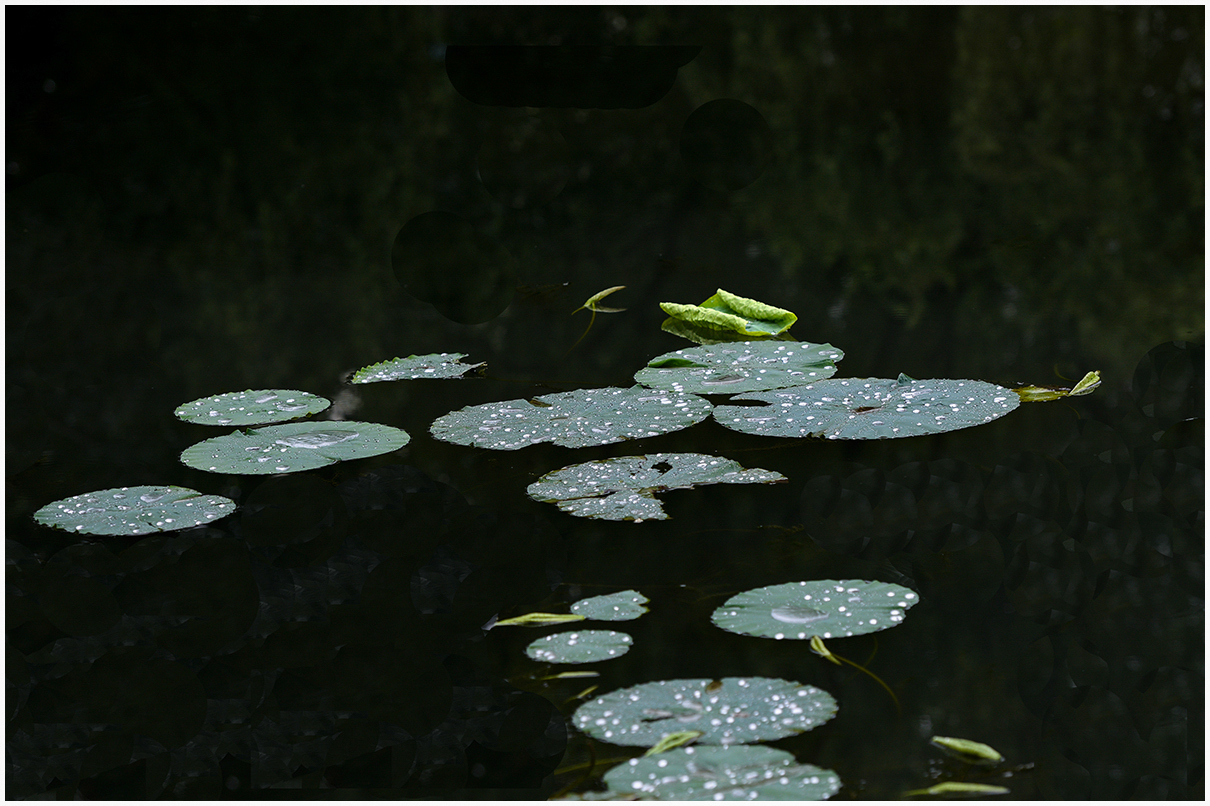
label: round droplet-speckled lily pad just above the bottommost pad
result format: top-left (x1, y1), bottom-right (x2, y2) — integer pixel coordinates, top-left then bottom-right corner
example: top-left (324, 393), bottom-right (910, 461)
top-left (571, 678), bottom-right (836, 747)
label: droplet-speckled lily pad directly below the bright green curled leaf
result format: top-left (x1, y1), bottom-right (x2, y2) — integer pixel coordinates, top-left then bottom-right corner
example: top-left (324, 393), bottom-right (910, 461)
top-left (634, 341), bottom-right (845, 395)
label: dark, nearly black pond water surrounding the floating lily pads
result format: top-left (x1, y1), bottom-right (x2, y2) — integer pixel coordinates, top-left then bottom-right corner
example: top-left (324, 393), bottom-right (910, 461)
top-left (6, 7), bottom-right (1204, 799)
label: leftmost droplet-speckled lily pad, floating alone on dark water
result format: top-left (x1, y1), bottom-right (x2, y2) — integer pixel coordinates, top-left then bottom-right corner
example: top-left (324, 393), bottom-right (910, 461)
top-left (34, 485), bottom-right (235, 535)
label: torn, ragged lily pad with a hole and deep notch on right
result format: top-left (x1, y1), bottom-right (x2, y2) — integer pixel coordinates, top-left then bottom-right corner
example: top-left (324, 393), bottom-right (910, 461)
top-left (526, 454), bottom-right (785, 523)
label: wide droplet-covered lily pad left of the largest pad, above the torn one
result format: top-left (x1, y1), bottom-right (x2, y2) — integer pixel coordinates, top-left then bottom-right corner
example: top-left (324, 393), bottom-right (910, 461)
top-left (430, 386), bottom-right (711, 450)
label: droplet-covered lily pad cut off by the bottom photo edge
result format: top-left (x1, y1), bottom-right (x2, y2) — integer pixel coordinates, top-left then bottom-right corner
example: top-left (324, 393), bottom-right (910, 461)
top-left (605, 745), bottom-right (840, 800)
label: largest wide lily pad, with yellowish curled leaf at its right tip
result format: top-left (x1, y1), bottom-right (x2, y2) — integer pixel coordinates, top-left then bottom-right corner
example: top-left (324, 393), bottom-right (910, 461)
top-left (714, 375), bottom-right (1021, 439)
